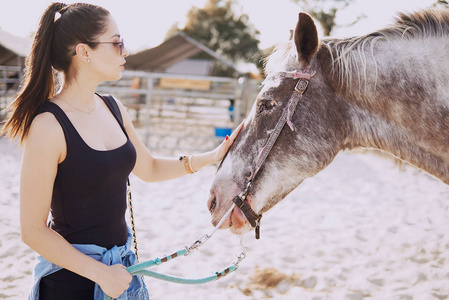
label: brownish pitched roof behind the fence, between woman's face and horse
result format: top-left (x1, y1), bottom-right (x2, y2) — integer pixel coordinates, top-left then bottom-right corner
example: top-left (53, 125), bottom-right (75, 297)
top-left (126, 32), bottom-right (241, 73)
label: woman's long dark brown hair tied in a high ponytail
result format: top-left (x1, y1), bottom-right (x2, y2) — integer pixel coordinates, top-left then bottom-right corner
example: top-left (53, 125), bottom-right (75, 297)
top-left (1, 3), bottom-right (109, 143)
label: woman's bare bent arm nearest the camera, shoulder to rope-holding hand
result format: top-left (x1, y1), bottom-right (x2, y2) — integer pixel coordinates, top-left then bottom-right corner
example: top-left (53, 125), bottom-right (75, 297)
top-left (20, 113), bottom-right (132, 298)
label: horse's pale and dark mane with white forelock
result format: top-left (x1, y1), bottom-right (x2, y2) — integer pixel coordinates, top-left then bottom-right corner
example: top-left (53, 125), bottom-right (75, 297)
top-left (265, 9), bottom-right (449, 89)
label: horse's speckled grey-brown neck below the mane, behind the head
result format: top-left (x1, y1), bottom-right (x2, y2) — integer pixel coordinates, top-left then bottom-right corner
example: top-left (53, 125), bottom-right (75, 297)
top-left (336, 41), bottom-right (449, 184)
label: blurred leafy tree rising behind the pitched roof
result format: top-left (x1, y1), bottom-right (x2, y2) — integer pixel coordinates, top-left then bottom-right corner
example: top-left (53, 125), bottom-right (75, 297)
top-left (171, 0), bottom-right (260, 76)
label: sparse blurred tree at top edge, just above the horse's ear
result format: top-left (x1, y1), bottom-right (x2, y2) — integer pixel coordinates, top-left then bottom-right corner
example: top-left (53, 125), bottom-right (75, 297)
top-left (292, 0), bottom-right (363, 36)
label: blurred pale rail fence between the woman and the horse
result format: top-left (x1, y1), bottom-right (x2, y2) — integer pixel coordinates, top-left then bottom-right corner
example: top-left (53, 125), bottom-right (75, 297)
top-left (97, 71), bottom-right (260, 154)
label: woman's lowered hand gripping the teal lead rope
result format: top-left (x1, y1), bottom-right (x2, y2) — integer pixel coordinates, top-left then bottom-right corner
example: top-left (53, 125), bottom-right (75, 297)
top-left (97, 264), bottom-right (132, 299)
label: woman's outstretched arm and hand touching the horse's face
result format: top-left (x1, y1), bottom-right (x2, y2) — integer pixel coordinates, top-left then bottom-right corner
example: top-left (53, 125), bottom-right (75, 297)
top-left (117, 101), bottom-right (243, 182)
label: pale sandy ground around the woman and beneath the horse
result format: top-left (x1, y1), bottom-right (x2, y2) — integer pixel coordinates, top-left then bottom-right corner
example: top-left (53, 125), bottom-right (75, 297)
top-left (0, 139), bottom-right (449, 300)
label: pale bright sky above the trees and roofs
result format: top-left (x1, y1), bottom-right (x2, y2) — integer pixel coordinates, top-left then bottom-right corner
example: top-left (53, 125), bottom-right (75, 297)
top-left (0, 0), bottom-right (436, 53)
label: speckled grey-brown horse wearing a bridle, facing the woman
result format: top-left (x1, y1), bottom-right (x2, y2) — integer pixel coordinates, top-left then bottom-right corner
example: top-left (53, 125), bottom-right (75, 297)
top-left (207, 10), bottom-right (449, 234)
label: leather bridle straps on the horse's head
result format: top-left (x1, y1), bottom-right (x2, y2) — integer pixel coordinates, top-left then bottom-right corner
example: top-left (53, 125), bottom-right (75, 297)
top-left (233, 68), bottom-right (315, 239)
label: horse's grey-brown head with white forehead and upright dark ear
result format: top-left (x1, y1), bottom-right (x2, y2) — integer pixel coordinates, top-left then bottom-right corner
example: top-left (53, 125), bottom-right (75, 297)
top-left (208, 13), bottom-right (345, 233)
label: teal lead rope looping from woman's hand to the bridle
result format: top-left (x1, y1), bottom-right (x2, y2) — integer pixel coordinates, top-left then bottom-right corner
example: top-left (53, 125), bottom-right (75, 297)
top-left (104, 204), bottom-right (247, 300)
